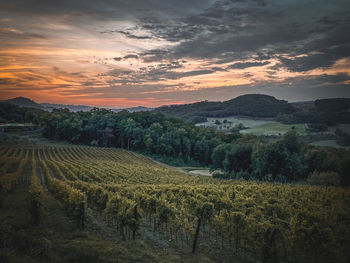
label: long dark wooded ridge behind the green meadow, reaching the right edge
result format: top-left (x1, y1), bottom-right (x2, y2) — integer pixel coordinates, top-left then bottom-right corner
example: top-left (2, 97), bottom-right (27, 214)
top-left (154, 94), bottom-right (350, 126)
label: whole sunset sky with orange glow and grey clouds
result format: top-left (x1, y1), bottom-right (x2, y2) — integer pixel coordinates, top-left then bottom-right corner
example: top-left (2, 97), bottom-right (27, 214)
top-left (0, 0), bottom-right (350, 107)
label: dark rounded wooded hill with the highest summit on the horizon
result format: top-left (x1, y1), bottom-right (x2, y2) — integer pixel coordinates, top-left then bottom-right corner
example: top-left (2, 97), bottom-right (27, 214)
top-left (154, 94), bottom-right (296, 122)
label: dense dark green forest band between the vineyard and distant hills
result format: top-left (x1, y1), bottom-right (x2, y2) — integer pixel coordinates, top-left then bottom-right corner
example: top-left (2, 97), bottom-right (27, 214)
top-left (0, 103), bottom-right (350, 185)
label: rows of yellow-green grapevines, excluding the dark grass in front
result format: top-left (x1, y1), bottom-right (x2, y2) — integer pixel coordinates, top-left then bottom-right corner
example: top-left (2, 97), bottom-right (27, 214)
top-left (0, 145), bottom-right (350, 262)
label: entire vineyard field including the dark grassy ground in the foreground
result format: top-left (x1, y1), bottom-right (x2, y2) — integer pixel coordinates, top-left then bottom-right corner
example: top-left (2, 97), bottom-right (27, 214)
top-left (0, 144), bottom-right (350, 263)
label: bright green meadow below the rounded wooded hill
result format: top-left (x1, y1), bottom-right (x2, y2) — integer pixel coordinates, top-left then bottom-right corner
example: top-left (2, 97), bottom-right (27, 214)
top-left (240, 122), bottom-right (306, 136)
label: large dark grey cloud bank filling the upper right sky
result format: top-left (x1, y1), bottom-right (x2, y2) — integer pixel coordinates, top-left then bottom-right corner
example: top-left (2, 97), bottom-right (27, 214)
top-left (128, 1), bottom-right (350, 71)
